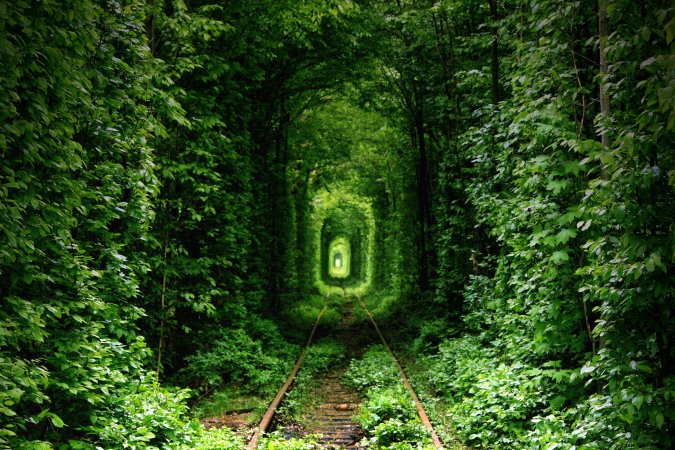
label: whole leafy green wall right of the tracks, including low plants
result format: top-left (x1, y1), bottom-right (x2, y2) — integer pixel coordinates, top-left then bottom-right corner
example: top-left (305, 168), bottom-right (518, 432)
top-left (373, 0), bottom-right (675, 449)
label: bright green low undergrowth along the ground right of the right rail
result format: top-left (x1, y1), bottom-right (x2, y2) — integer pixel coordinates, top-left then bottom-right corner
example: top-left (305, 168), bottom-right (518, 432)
top-left (410, 279), bottom-right (672, 450)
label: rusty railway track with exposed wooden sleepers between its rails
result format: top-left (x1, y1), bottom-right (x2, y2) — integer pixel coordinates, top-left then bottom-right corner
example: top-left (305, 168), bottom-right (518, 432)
top-left (246, 290), bottom-right (443, 450)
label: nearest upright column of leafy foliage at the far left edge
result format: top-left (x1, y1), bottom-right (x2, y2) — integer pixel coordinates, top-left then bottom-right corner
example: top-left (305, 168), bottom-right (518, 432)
top-left (0, 1), bottom-right (158, 448)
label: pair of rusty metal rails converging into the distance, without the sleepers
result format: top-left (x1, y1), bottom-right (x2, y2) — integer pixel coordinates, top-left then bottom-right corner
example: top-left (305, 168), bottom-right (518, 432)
top-left (246, 289), bottom-right (443, 450)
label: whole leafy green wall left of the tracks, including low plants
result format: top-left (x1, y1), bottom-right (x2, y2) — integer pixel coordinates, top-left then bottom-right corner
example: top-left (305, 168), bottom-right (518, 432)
top-left (0, 0), bottom-right (362, 448)
